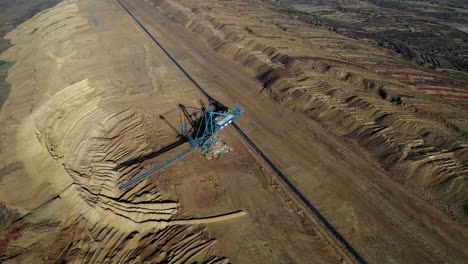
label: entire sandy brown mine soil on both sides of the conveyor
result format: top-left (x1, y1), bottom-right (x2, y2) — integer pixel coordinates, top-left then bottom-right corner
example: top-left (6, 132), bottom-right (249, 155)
top-left (0, 0), bottom-right (468, 263)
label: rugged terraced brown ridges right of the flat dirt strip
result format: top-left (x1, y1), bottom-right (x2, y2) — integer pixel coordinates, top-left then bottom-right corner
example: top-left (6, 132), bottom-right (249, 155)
top-left (150, 0), bottom-right (468, 224)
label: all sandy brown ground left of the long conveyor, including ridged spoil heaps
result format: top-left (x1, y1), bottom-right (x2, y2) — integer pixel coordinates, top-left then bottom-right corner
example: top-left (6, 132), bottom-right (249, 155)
top-left (0, 1), bottom-right (341, 263)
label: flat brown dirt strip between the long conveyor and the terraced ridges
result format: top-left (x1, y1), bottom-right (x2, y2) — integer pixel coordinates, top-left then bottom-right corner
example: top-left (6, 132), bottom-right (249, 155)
top-left (119, 1), bottom-right (466, 263)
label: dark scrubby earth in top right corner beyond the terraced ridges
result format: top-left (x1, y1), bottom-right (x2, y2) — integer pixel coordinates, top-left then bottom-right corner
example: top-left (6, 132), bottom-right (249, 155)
top-left (267, 0), bottom-right (468, 72)
